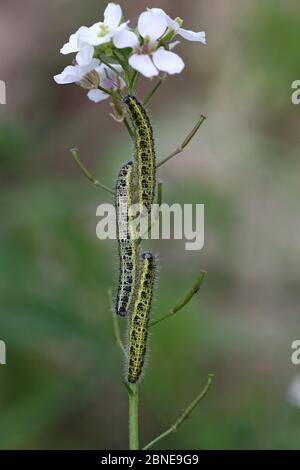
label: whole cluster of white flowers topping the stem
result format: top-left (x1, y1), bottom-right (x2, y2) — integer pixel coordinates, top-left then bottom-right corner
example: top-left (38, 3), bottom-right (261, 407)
top-left (54, 3), bottom-right (206, 102)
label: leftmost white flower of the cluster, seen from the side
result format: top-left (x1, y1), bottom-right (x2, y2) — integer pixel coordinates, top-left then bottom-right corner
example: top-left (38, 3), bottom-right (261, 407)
top-left (54, 45), bottom-right (100, 85)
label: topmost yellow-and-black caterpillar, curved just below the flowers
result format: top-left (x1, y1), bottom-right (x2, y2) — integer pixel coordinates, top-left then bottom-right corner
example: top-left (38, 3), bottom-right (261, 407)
top-left (124, 95), bottom-right (156, 213)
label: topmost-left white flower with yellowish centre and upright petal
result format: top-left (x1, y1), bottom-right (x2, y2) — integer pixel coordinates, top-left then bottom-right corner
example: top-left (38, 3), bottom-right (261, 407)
top-left (78, 3), bottom-right (127, 46)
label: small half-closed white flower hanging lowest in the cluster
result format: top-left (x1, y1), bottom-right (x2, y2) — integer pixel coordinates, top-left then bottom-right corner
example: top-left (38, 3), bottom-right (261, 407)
top-left (88, 64), bottom-right (125, 103)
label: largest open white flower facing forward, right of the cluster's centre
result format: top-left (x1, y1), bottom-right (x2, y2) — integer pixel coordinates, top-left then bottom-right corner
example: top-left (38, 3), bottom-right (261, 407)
top-left (113, 11), bottom-right (184, 77)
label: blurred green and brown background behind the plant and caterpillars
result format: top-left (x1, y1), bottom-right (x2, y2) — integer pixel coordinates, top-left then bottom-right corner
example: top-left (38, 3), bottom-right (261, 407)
top-left (0, 0), bottom-right (300, 449)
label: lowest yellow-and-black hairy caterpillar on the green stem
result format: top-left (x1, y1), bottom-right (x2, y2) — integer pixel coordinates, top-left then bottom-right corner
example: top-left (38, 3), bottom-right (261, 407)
top-left (127, 252), bottom-right (156, 383)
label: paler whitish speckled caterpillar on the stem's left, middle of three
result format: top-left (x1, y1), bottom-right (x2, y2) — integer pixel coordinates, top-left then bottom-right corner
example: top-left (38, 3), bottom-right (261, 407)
top-left (115, 162), bottom-right (138, 317)
